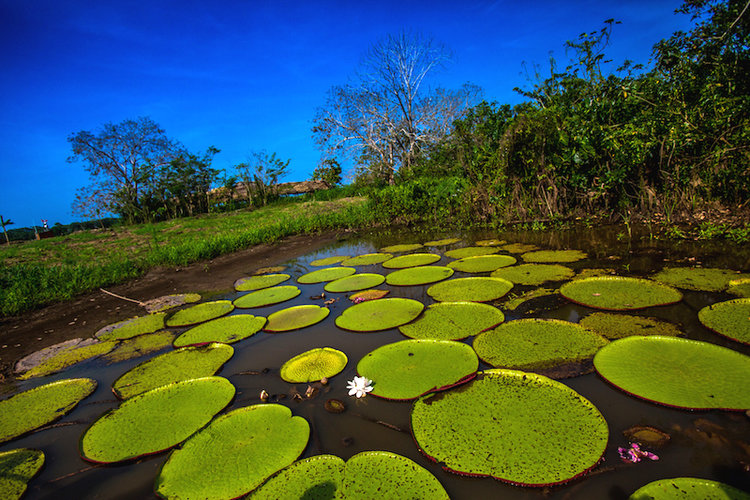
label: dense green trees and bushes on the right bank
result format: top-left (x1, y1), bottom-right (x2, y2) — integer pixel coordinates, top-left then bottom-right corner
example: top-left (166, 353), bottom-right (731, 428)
top-left (362, 0), bottom-right (750, 222)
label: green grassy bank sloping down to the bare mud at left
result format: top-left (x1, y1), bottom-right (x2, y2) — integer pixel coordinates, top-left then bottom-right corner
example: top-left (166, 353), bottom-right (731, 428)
top-left (0, 198), bottom-right (373, 316)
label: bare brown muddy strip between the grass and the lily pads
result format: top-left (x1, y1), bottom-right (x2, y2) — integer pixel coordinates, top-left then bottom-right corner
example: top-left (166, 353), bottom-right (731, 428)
top-left (0, 232), bottom-right (351, 381)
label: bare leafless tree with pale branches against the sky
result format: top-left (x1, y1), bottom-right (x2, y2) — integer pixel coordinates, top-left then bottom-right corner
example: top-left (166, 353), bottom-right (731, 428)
top-left (313, 33), bottom-right (479, 183)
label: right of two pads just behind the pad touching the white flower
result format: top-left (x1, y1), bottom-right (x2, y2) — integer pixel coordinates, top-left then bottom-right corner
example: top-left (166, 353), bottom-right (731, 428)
top-left (398, 302), bottom-right (505, 340)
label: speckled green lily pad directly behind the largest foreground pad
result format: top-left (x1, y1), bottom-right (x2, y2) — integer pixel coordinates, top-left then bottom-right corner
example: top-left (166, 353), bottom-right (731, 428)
top-left (473, 319), bottom-right (608, 378)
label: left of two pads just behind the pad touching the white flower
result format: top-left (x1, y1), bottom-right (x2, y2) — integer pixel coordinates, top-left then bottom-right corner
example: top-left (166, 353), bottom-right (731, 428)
top-left (336, 298), bottom-right (424, 332)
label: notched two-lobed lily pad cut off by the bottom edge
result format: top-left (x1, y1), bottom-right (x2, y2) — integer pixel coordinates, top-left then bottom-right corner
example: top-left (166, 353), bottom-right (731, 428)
top-left (248, 451), bottom-right (448, 500)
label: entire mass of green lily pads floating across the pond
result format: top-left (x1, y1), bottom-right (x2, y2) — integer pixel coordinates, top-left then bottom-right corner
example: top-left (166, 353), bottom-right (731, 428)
top-left (0, 238), bottom-right (750, 498)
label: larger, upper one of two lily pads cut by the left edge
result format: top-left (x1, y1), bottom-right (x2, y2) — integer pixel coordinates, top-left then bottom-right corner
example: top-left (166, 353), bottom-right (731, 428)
top-left (0, 378), bottom-right (96, 443)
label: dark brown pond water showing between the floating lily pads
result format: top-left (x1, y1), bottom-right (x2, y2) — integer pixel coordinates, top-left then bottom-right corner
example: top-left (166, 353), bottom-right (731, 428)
top-left (0, 227), bottom-right (750, 499)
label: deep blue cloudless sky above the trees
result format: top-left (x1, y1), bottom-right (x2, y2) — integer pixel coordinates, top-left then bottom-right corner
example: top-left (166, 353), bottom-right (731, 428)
top-left (0, 0), bottom-right (691, 227)
